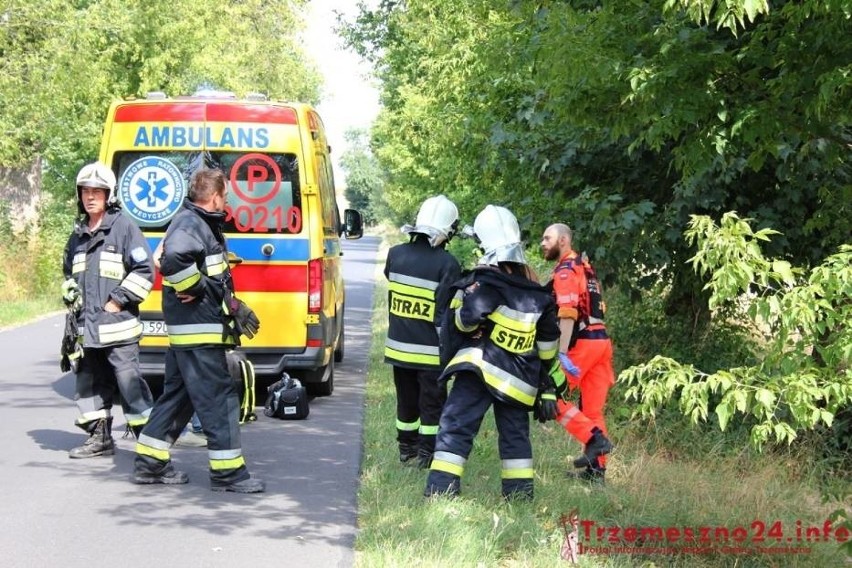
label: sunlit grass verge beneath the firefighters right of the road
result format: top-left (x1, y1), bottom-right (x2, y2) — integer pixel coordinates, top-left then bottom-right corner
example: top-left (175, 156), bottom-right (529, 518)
top-left (355, 248), bottom-right (848, 568)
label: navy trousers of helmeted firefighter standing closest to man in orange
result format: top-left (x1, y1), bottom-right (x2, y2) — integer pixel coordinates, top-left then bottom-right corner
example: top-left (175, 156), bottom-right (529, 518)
top-left (424, 371), bottom-right (534, 498)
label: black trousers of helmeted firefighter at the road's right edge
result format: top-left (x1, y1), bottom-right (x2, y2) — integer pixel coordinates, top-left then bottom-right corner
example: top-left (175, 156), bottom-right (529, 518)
top-left (393, 365), bottom-right (447, 454)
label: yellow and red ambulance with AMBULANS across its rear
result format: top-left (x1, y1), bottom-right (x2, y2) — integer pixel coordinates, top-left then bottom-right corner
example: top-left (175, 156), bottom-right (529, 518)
top-left (100, 92), bottom-right (362, 396)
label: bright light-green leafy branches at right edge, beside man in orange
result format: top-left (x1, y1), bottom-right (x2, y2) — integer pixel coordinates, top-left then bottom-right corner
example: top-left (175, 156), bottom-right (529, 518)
top-left (619, 213), bottom-right (852, 449)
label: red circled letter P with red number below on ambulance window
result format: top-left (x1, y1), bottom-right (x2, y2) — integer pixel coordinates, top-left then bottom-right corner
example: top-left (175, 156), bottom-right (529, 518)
top-left (225, 153), bottom-right (302, 233)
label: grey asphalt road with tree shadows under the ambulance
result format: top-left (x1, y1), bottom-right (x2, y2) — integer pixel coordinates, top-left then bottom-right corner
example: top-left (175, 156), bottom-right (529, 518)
top-left (0, 233), bottom-right (378, 568)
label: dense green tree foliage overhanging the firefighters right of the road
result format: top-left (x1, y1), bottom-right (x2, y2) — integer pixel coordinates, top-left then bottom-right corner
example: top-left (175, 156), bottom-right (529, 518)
top-left (346, 0), bottom-right (852, 312)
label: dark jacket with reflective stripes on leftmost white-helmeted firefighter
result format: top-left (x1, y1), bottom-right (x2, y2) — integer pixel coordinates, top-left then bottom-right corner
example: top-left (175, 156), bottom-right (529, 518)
top-left (62, 207), bottom-right (154, 348)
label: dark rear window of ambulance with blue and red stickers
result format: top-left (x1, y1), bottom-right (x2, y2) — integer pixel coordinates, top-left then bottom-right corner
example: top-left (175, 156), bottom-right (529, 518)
top-left (114, 151), bottom-right (302, 234)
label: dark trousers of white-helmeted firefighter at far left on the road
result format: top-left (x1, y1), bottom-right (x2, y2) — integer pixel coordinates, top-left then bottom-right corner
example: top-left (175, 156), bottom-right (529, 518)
top-left (74, 343), bottom-right (154, 433)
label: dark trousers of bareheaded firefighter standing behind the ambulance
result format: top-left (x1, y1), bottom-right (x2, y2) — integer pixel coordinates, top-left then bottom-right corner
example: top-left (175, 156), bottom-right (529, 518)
top-left (135, 347), bottom-right (251, 484)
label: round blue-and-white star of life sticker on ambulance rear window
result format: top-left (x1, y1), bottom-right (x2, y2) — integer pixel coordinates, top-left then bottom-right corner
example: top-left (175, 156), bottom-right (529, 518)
top-left (118, 156), bottom-right (186, 227)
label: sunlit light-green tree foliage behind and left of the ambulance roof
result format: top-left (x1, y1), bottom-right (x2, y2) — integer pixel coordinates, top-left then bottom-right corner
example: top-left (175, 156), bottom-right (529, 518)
top-left (0, 0), bottom-right (319, 191)
